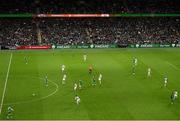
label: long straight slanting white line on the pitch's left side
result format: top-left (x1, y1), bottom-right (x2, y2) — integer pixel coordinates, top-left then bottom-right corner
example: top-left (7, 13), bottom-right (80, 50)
top-left (0, 53), bottom-right (12, 115)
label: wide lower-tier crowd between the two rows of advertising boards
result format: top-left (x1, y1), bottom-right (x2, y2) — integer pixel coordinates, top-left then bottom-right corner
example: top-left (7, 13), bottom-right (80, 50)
top-left (0, 18), bottom-right (180, 46)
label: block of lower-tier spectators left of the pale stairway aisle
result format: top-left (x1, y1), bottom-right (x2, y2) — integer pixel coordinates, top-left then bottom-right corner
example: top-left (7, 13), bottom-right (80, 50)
top-left (0, 19), bottom-right (37, 45)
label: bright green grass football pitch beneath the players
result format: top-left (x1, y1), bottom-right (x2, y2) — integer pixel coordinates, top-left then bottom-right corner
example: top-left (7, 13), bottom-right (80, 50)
top-left (0, 48), bottom-right (180, 120)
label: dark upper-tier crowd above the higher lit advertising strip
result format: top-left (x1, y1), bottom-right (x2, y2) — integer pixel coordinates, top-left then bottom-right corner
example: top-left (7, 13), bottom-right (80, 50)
top-left (0, 0), bottom-right (180, 14)
